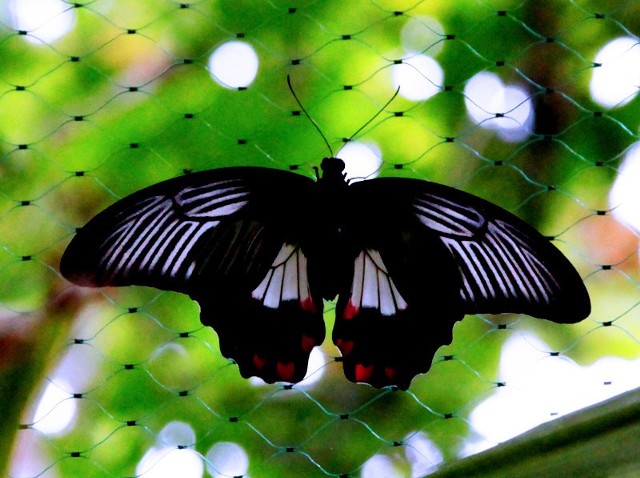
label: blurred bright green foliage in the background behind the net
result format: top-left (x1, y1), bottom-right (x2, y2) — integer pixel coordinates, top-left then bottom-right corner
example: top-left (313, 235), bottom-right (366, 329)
top-left (0, 0), bottom-right (640, 477)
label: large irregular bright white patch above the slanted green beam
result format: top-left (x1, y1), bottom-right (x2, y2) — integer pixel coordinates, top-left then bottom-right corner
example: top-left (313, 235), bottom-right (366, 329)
top-left (464, 333), bottom-right (640, 446)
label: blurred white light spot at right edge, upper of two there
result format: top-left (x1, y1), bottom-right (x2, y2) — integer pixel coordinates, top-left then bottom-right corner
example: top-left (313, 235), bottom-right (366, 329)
top-left (589, 37), bottom-right (640, 108)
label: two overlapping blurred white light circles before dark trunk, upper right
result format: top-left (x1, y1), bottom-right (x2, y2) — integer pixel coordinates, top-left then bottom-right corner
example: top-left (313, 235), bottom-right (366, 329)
top-left (464, 71), bottom-right (534, 141)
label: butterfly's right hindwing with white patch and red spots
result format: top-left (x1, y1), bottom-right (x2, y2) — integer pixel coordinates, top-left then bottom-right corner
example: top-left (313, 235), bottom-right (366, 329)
top-left (333, 205), bottom-right (463, 389)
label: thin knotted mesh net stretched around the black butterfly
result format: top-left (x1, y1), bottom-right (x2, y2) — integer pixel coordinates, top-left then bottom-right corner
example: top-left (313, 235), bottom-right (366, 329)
top-left (0, 0), bottom-right (640, 478)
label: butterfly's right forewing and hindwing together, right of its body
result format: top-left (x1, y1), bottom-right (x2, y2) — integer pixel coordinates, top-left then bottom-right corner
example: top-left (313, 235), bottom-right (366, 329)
top-left (333, 178), bottom-right (590, 388)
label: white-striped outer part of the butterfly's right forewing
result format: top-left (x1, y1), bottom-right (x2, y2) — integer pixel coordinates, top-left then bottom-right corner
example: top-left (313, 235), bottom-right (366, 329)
top-left (410, 182), bottom-right (591, 323)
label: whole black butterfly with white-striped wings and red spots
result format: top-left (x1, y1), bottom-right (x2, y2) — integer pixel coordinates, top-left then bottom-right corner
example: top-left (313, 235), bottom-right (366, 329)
top-left (60, 158), bottom-right (591, 389)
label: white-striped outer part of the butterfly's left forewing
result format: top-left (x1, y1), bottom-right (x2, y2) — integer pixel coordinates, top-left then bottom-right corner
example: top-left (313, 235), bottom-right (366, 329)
top-left (60, 170), bottom-right (256, 292)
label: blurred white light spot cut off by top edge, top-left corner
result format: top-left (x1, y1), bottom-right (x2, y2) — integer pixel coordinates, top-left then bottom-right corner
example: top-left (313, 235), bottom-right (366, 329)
top-left (9, 0), bottom-right (75, 43)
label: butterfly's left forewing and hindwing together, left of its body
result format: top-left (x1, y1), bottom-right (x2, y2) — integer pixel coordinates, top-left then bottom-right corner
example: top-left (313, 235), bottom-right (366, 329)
top-left (60, 168), bottom-right (325, 382)
